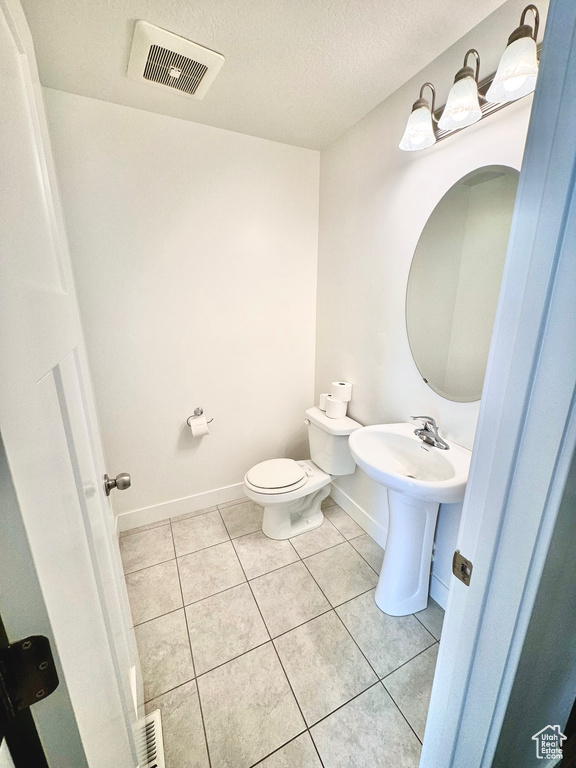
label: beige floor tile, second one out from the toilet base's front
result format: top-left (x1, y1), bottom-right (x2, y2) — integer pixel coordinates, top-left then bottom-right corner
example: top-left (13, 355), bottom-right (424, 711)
top-left (250, 562), bottom-right (331, 637)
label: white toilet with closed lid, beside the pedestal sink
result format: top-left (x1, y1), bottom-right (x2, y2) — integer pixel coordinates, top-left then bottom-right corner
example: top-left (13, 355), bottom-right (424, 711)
top-left (244, 408), bottom-right (362, 539)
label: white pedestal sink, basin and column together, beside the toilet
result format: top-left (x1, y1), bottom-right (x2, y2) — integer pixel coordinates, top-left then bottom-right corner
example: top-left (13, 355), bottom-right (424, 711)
top-left (350, 424), bottom-right (471, 616)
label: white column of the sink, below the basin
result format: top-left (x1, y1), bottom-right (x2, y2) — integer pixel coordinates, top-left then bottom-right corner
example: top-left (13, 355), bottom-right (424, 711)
top-left (375, 488), bottom-right (439, 616)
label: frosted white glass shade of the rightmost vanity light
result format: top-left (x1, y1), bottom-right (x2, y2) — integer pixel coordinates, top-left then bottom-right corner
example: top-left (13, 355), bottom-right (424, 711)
top-left (486, 37), bottom-right (538, 104)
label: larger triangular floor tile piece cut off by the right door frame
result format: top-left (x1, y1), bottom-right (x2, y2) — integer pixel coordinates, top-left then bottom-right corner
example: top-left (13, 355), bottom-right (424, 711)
top-left (382, 643), bottom-right (438, 740)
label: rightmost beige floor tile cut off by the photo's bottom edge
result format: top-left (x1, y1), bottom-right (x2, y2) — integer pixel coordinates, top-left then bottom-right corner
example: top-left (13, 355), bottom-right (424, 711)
top-left (311, 683), bottom-right (421, 768)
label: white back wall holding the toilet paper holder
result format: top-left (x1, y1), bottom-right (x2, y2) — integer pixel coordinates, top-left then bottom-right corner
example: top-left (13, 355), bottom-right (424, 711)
top-left (45, 89), bottom-right (319, 527)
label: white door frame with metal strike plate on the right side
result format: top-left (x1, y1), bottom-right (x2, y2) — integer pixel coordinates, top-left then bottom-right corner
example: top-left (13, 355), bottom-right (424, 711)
top-left (420, 0), bottom-right (576, 768)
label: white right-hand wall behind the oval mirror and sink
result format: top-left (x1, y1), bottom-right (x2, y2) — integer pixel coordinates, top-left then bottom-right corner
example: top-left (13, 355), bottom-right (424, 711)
top-left (316, 0), bottom-right (546, 600)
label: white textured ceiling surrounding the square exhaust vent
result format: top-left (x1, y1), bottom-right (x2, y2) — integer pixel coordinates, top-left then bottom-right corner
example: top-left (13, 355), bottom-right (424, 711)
top-left (22, 0), bottom-right (503, 149)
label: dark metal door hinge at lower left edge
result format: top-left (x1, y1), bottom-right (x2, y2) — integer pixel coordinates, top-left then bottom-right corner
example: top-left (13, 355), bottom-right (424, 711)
top-left (0, 635), bottom-right (58, 718)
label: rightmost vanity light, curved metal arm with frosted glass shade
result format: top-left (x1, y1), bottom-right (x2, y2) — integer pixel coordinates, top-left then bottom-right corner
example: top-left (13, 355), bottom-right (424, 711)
top-left (486, 5), bottom-right (540, 104)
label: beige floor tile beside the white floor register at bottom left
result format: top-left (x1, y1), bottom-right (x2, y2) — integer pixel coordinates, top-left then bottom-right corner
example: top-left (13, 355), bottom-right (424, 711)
top-left (146, 680), bottom-right (209, 768)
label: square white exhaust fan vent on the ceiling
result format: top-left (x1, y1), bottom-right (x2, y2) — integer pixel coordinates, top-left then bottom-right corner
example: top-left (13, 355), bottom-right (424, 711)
top-left (128, 21), bottom-right (224, 99)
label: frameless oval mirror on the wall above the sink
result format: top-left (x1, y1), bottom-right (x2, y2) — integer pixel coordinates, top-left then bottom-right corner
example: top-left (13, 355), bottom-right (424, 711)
top-left (406, 165), bottom-right (519, 403)
